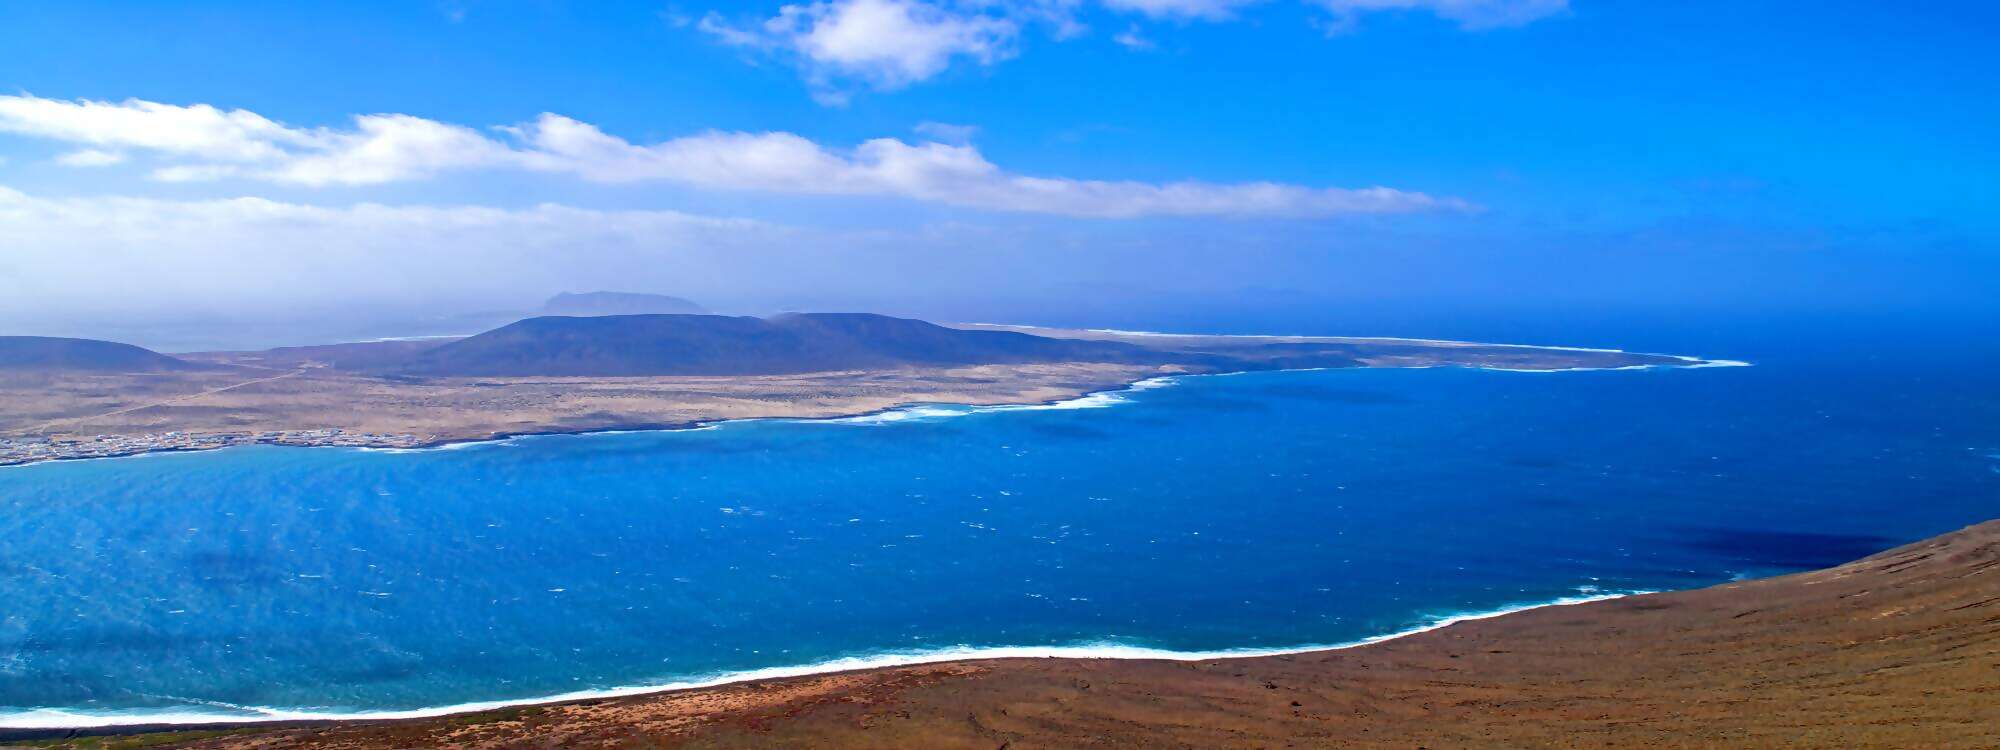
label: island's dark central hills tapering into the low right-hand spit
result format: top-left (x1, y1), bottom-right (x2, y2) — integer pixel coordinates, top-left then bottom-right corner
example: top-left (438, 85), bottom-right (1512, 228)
top-left (114, 312), bottom-right (1702, 378)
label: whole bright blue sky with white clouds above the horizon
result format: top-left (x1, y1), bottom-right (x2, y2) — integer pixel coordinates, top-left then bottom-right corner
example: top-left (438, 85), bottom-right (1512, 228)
top-left (0, 0), bottom-right (2000, 346)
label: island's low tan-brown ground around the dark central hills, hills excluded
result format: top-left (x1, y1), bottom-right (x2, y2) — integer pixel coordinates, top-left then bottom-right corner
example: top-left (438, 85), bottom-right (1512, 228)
top-left (0, 326), bottom-right (1698, 464)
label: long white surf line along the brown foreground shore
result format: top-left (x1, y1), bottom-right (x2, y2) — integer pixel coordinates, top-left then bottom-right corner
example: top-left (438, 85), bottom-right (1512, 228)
top-left (0, 590), bottom-right (1656, 730)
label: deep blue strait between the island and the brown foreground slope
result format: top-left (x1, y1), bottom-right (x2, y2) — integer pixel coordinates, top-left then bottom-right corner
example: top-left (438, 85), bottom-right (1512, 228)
top-left (0, 336), bottom-right (2000, 724)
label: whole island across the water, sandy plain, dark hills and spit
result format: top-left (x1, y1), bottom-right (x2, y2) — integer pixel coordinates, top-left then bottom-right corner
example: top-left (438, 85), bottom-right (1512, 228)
top-left (0, 312), bottom-right (1718, 466)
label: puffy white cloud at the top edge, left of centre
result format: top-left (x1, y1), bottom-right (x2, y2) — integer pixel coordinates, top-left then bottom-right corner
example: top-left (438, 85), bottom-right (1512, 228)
top-left (700, 0), bottom-right (1020, 96)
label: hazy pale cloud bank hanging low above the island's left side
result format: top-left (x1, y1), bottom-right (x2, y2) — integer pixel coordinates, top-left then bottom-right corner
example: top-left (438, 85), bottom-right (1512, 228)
top-left (0, 188), bottom-right (788, 334)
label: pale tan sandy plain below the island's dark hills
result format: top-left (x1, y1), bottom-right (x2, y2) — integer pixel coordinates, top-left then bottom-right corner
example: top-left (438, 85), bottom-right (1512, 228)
top-left (0, 362), bottom-right (1172, 442)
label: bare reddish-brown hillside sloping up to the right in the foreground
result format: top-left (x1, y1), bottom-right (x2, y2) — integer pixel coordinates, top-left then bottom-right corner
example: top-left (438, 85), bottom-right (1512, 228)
top-left (19, 522), bottom-right (2000, 748)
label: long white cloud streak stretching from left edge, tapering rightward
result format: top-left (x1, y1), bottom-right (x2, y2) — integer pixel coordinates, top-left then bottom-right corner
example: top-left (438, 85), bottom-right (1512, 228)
top-left (0, 96), bottom-right (1468, 218)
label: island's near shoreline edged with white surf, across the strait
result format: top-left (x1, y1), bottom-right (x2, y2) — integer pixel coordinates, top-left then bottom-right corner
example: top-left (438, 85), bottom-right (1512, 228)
top-left (0, 348), bottom-right (1750, 470)
